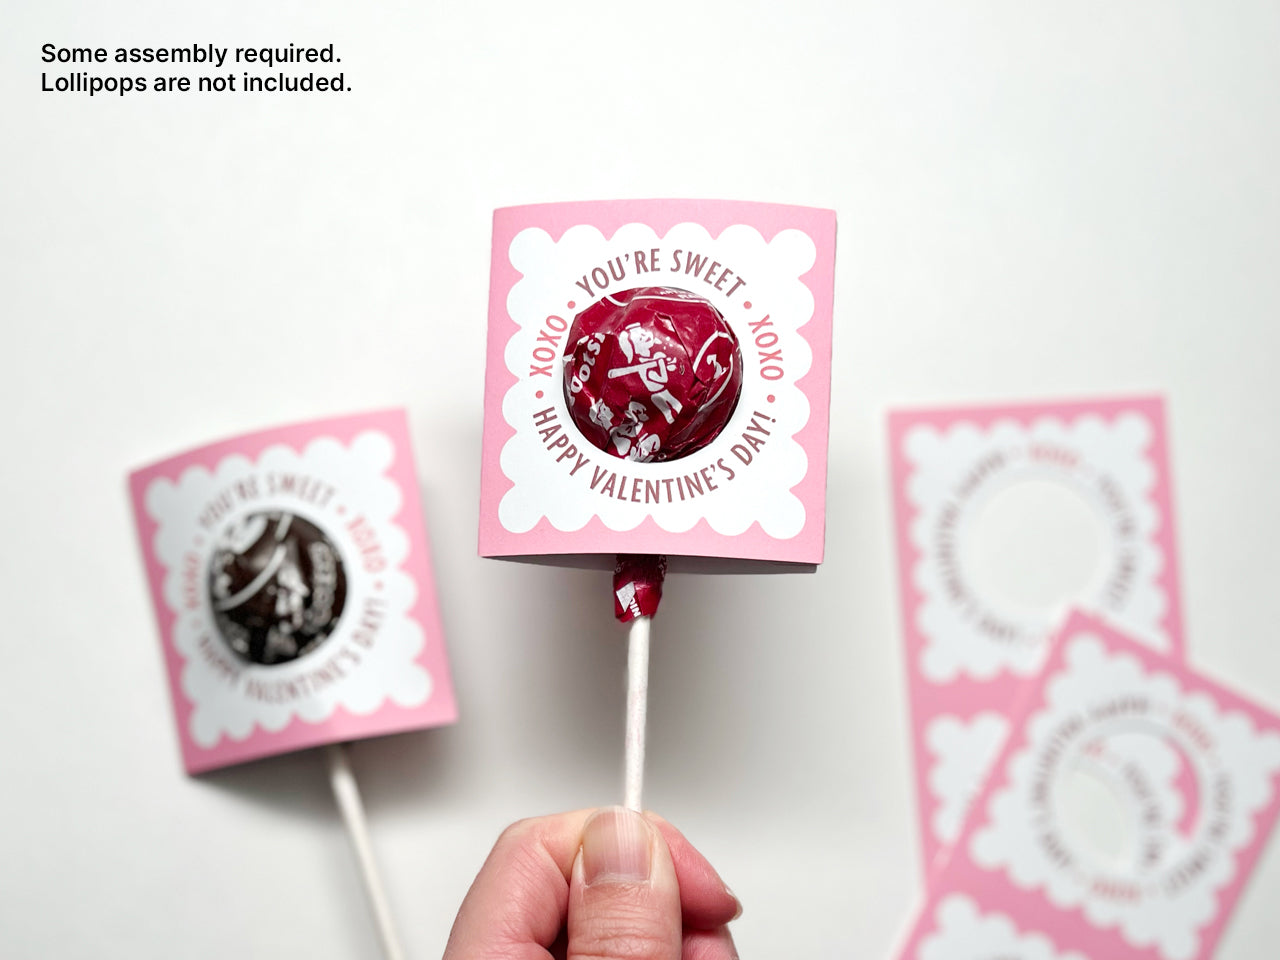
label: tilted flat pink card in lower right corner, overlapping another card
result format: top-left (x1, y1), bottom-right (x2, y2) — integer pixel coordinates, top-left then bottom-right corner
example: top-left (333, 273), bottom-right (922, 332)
top-left (901, 613), bottom-right (1280, 960)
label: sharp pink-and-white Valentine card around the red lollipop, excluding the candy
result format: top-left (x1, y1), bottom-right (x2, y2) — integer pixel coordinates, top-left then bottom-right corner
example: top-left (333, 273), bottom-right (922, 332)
top-left (480, 200), bottom-right (836, 564)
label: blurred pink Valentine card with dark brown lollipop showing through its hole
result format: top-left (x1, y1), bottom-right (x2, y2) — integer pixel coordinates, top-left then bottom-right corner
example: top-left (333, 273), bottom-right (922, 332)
top-left (129, 410), bottom-right (457, 773)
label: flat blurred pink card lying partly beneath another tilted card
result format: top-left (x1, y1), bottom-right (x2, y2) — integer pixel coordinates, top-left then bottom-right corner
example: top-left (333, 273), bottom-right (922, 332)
top-left (890, 397), bottom-right (1183, 870)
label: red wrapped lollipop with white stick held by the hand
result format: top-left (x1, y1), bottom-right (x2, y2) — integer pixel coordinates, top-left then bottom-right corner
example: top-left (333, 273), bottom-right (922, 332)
top-left (564, 287), bottom-right (742, 810)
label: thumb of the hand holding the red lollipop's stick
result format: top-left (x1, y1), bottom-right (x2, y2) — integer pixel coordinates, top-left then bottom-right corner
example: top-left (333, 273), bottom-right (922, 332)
top-left (568, 806), bottom-right (682, 960)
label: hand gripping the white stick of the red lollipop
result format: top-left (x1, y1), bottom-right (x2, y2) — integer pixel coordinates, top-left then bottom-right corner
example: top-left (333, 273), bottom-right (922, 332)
top-left (443, 806), bottom-right (741, 960)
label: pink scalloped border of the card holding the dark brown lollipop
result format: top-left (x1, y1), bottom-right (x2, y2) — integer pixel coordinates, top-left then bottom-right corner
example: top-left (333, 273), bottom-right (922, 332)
top-left (129, 408), bottom-right (458, 773)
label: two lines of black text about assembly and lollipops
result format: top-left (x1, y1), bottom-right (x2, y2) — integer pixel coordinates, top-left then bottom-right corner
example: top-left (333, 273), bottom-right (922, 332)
top-left (40, 44), bottom-right (351, 96)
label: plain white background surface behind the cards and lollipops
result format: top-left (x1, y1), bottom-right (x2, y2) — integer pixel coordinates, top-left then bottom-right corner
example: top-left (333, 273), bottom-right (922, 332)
top-left (0, 0), bottom-right (1280, 960)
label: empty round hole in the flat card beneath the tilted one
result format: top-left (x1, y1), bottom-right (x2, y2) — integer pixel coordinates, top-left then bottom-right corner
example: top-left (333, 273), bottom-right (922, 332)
top-left (968, 480), bottom-right (1105, 612)
